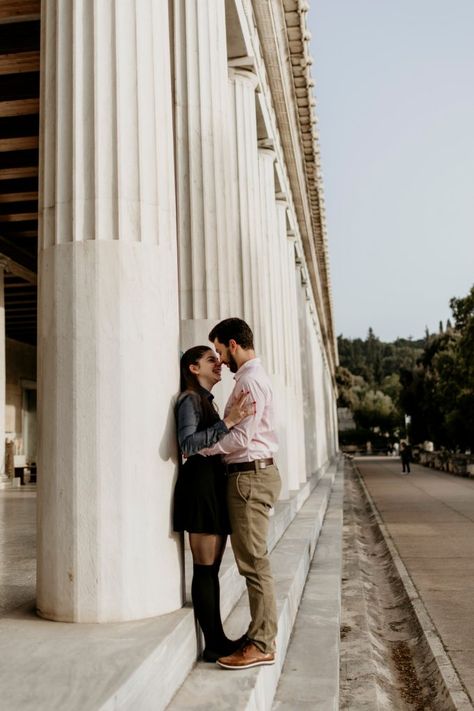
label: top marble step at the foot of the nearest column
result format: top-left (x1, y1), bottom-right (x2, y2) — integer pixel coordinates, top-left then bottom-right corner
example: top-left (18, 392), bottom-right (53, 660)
top-left (0, 458), bottom-right (335, 711)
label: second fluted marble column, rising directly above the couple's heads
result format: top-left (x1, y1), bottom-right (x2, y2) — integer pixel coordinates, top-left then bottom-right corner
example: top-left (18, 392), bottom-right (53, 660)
top-left (173, 0), bottom-right (234, 350)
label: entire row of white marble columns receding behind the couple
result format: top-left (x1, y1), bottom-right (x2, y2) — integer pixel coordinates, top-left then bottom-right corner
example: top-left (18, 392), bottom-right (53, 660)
top-left (36, 0), bottom-right (336, 622)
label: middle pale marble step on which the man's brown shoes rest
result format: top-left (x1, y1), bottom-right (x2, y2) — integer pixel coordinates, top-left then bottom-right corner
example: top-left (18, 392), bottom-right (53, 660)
top-left (167, 469), bottom-right (336, 711)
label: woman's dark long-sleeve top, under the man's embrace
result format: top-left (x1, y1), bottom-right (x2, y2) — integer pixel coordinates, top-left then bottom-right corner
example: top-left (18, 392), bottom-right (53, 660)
top-left (176, 388), bottom-right (229, 457)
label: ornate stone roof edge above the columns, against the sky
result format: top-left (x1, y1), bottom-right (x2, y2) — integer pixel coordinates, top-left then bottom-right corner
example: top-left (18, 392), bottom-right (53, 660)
top-left (252, 0), bottom-right (338, 373)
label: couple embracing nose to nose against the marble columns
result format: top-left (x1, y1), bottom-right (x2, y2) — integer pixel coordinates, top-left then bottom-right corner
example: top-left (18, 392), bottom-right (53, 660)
top-left (173, 318), bottom-right (281, 669)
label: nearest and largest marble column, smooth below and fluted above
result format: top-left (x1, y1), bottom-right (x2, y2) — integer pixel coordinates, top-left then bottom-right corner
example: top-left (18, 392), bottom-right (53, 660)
top-left (38, 0), bottom-right (182, 622)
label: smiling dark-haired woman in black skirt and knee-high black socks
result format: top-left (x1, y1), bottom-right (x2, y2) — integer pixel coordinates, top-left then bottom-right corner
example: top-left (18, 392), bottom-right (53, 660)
top-left (173, 346), bottom-right (253, 662)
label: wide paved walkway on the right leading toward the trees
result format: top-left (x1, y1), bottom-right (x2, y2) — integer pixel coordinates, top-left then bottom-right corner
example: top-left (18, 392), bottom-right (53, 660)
top-left (356, 457), bottom-right (474, 699)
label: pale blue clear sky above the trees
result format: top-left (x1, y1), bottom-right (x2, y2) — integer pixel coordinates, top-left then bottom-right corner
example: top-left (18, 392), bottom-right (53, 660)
top-left (307, 0), bottom-right (474, 341)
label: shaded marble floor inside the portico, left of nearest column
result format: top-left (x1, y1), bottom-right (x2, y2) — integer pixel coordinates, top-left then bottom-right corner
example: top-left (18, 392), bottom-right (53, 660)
top-left (0, 486), bottom-right (36, 616)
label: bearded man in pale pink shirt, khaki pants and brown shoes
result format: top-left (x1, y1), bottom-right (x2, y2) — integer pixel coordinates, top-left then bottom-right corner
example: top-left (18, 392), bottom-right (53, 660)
top-left (200, 318), bottom-right (281, 669)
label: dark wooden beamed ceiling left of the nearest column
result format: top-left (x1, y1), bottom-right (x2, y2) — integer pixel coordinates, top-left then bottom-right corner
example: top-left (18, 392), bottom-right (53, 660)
top-left (0, 0), bottom-right (41, 343)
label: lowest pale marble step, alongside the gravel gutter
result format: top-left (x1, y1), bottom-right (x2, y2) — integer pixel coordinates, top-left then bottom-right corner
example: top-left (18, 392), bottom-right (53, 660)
top-left (273, 472), bottom-right (344, 711)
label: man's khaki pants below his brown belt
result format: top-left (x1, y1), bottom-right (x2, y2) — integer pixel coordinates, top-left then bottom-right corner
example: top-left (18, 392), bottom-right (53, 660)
top-left (227, 465), bottom-right (281, 654)
